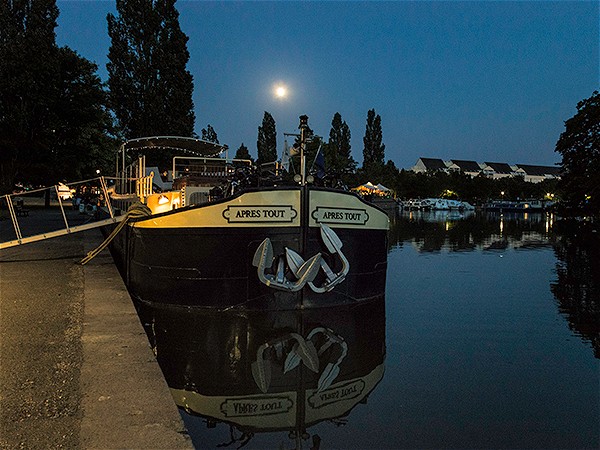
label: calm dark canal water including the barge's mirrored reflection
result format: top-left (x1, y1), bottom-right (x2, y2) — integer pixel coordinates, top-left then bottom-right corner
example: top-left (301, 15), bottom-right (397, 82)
top-left (140, 212), bottom-right (600, 449)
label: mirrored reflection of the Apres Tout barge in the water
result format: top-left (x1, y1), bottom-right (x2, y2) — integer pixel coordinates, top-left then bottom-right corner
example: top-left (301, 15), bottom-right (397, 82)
top-left (137, 295), bottom-right (386, 448)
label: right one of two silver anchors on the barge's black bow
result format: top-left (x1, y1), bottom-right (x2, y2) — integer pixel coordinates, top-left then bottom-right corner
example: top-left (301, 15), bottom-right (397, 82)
top-left (285, 224), bottom-right (350, 294)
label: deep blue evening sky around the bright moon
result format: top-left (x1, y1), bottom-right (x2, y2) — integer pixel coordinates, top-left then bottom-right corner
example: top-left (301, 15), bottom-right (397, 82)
top-left (56, 0), bottom-right (600, 168)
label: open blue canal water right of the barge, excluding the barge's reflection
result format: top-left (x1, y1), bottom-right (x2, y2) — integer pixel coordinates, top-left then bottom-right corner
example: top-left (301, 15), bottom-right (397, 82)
top-left (144, 212), bottom-right (600, 449)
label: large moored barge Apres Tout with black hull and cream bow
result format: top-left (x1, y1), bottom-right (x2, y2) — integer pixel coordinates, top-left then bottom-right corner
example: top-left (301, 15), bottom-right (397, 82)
top-left (106, 116), bottom-right (389, 309)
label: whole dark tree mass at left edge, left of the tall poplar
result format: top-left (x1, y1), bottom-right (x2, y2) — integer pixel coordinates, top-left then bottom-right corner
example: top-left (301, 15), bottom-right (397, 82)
top-left (0, 0), bottom-right (112, 192)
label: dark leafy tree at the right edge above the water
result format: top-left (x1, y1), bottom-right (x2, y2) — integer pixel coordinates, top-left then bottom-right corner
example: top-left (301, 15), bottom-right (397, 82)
top-left (555, 91), bottom-right (600, 215)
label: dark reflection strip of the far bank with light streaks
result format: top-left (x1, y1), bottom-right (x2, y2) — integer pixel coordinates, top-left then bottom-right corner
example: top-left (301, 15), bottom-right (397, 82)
top-left (389, 211), bottom-right (554, 252)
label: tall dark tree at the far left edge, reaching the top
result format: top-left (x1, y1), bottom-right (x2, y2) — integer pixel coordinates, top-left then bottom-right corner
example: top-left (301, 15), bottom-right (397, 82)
top-left (0, 0), bottom-right (58, 192)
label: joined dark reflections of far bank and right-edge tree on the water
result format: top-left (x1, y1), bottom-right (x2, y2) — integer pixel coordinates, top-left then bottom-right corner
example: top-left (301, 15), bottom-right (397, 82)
top-left (390, 211), bottom-right (600, 358)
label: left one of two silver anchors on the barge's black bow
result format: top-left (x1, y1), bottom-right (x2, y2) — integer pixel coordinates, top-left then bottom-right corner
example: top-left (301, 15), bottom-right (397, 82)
top-left (252, 238), bottom-right (322, 292)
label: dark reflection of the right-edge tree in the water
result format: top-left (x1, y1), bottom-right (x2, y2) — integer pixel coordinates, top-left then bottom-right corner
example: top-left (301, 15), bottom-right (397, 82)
top-left (552, 224), bottom-right (600, 358)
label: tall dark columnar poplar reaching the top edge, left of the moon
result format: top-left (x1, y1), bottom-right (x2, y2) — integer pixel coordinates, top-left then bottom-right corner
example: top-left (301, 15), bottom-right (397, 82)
top-left (107, 0), bottom-right (195, 139)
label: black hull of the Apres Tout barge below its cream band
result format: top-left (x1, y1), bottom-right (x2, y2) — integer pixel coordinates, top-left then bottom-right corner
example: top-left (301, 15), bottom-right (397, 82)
top-left (105, 186), bottom-right (387, 310)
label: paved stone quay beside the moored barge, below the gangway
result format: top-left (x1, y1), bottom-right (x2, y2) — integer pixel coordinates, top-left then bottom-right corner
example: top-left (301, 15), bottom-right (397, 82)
top-left (0, 227), bottom-right (193, 449)
